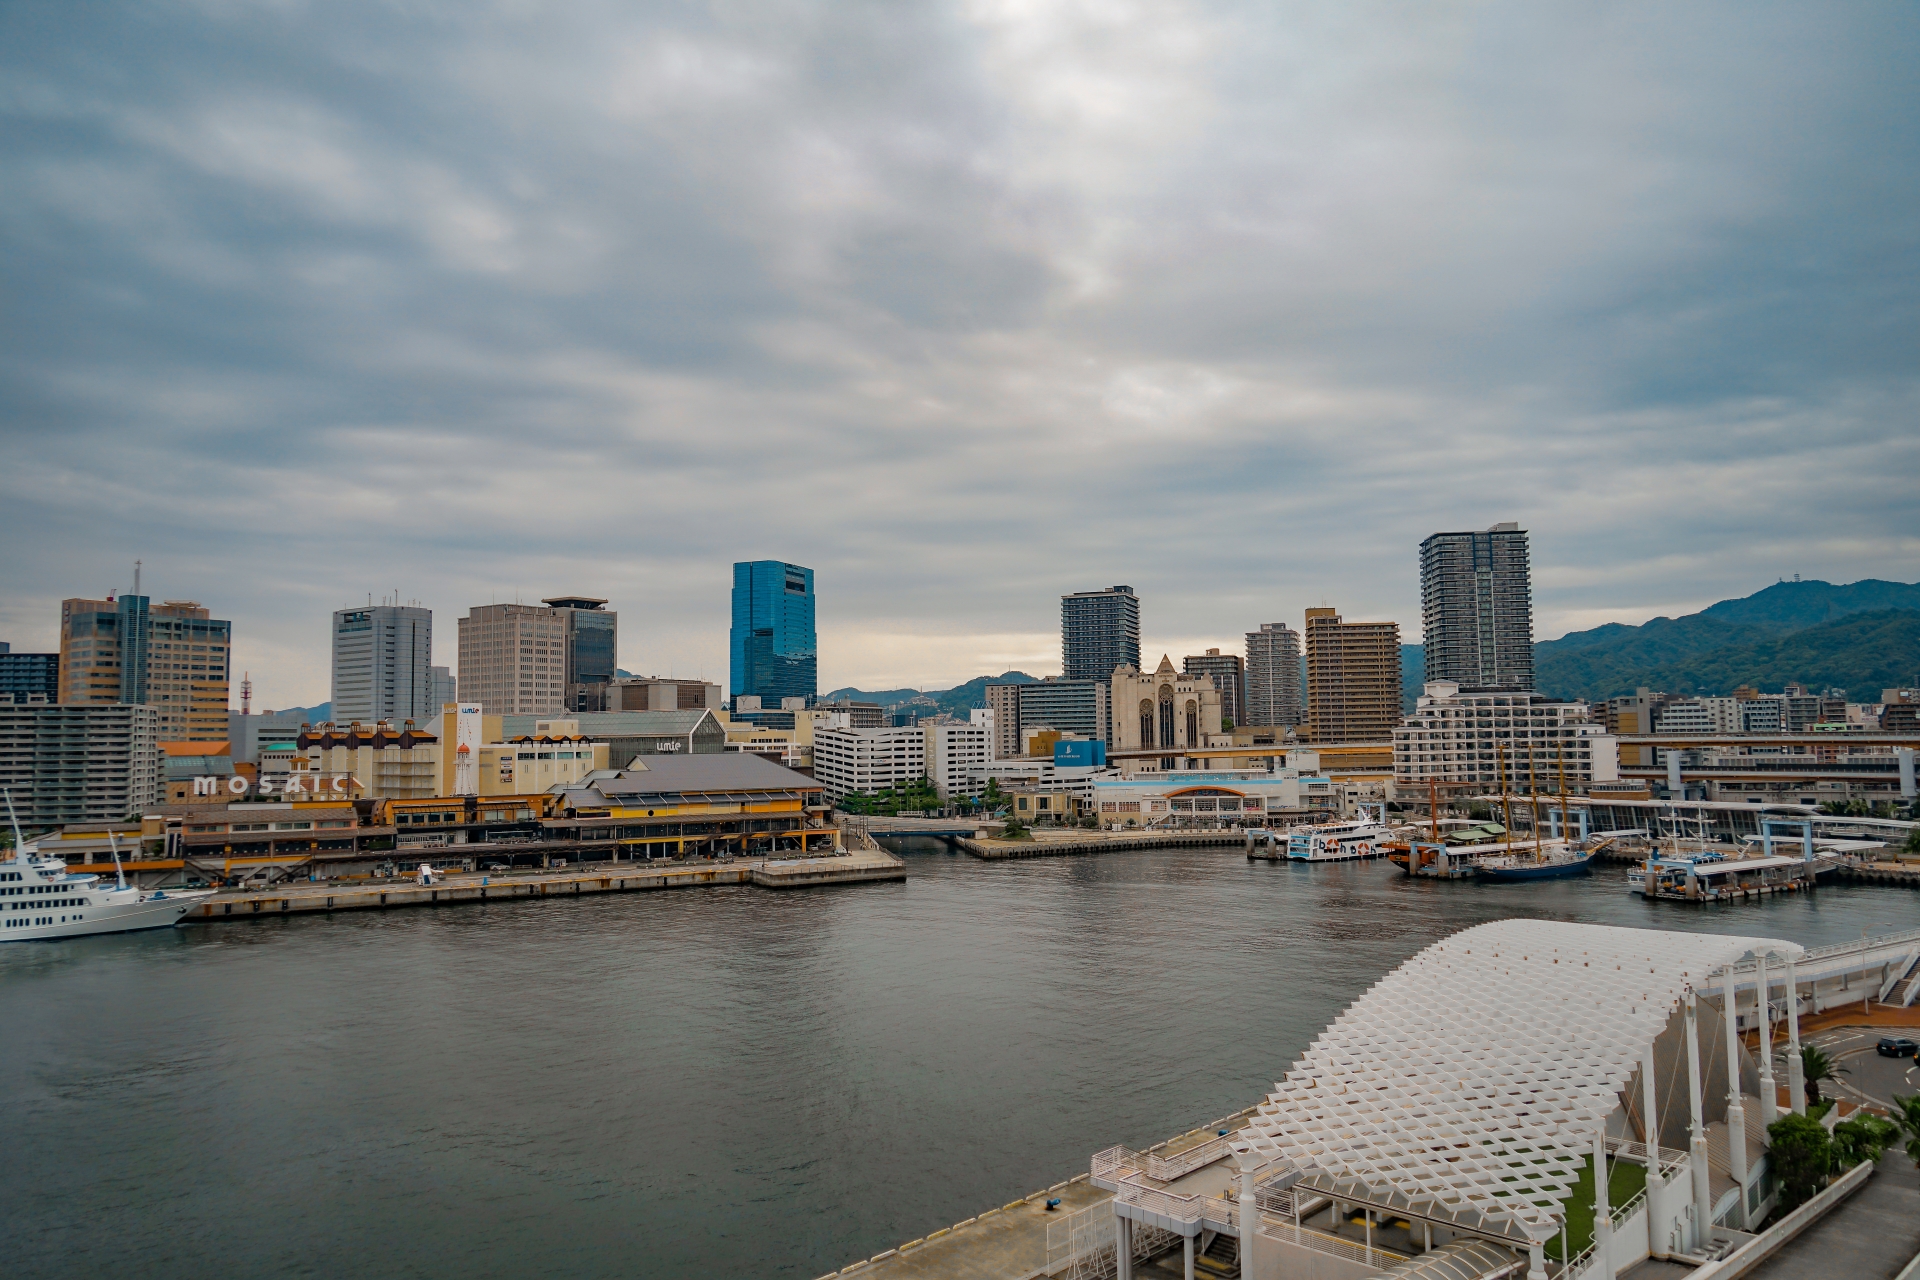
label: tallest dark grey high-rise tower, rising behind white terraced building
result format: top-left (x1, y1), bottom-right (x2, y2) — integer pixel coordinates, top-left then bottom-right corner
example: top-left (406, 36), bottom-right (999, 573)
top-left (1421, 520), bottom-right (1534, 691)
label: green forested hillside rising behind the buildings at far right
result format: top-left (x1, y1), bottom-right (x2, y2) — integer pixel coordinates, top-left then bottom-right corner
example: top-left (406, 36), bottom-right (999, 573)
top-left (1534, 580), bottom-right (1920, 700)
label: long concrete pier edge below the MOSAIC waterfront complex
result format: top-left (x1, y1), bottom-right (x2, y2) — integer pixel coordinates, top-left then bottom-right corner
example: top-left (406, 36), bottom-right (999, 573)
top-left (182, 850), bottom-right (906, 923)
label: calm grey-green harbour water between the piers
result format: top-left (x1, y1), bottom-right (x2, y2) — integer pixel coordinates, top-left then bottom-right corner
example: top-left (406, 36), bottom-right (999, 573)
top-left (0, 842), bottom-right (1920, 1278)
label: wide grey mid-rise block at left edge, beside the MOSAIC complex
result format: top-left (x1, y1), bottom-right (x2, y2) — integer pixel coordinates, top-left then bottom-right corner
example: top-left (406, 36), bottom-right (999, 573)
top-left (0, 702), bottom-right (161, 835)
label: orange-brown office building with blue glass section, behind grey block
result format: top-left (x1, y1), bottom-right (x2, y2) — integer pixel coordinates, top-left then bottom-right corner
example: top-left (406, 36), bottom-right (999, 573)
top-left (60, 593), bottom-right (232, 743)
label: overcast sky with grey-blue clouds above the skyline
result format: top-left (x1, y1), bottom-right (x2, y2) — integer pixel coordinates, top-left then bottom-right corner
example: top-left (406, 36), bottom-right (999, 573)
top-left (0, 0), bottom-right (1920, 706)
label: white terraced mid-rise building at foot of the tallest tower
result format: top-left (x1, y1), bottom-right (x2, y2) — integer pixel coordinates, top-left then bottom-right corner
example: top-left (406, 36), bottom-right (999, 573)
top-left (1394, 679), bottom-right (1620, 796)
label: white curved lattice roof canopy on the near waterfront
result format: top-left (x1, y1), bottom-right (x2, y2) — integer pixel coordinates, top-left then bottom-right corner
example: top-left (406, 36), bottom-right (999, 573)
top-left (1235, 919), bottom-right (1803, 1242)
